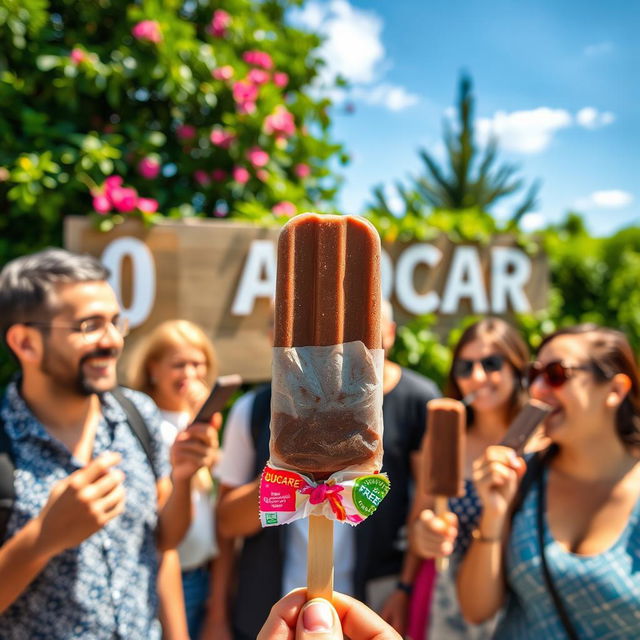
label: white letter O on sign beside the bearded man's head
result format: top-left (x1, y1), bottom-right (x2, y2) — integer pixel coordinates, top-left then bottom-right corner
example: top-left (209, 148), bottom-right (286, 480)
top-left (101, 238), bottom-right (156, 328)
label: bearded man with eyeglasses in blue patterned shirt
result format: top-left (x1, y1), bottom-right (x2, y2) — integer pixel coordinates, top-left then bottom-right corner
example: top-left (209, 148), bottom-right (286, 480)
top-left (0, 249), bottom-right (216, 640)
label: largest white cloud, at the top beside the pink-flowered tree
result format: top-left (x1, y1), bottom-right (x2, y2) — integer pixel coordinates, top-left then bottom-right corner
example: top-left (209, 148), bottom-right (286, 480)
top-left (291, 0), bottom-right (419, 111)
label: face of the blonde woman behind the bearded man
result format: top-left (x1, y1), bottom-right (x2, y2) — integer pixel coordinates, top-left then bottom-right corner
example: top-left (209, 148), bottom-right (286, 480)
top-left (148, 343), bottom-right (209, 411)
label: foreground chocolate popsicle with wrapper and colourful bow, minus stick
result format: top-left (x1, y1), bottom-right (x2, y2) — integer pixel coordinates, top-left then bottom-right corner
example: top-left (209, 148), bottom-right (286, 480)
top-left (260, 214), bottom-right (388, 525)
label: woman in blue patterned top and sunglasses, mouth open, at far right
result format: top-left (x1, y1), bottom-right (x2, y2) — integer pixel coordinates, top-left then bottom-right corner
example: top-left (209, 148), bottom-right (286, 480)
top-left (458, 324), bottom-right (640, 640)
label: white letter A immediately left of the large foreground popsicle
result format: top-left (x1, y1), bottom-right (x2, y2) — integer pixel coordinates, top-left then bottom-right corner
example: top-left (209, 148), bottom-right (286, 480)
top-left (231, 240), bottom-right (276, 316)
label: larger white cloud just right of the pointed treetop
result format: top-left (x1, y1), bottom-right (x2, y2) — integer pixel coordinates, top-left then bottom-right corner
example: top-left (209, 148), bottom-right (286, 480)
top-left (476, 107), bottom-right (573, 153)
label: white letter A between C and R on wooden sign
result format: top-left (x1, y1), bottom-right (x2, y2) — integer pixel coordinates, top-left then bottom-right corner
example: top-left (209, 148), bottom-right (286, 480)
top-left (440, 247), bottom-right (489, 313)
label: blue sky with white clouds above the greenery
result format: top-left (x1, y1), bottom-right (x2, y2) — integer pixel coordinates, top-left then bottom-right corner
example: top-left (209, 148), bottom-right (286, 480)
top-left (295, 0), bottom-right (640, 235)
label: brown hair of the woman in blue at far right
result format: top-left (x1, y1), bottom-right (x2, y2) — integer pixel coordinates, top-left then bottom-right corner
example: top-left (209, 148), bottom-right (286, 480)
top-left (538, 322), bottom-right (640, 447)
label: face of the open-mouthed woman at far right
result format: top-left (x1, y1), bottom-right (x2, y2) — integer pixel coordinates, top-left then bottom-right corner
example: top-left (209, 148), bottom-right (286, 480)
top-left (529, 334), bottom-right (614, 444)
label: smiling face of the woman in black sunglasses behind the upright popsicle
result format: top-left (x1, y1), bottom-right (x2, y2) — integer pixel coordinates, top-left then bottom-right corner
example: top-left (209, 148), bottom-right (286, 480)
top-left (454, 337), bottom-right (516, 414)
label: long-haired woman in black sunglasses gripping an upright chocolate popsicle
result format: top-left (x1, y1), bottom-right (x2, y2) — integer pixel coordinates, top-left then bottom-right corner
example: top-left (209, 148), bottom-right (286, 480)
top-left (411, 318), bottom-right (529, 640)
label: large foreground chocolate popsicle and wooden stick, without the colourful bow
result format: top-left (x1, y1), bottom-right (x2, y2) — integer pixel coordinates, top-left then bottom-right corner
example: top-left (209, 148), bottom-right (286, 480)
top-left (270, 214), bottom-right (382, 599)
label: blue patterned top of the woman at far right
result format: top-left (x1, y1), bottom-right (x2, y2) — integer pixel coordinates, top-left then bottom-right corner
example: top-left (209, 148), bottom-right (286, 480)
top-left (495, 469), bottom-right (640, 640)
